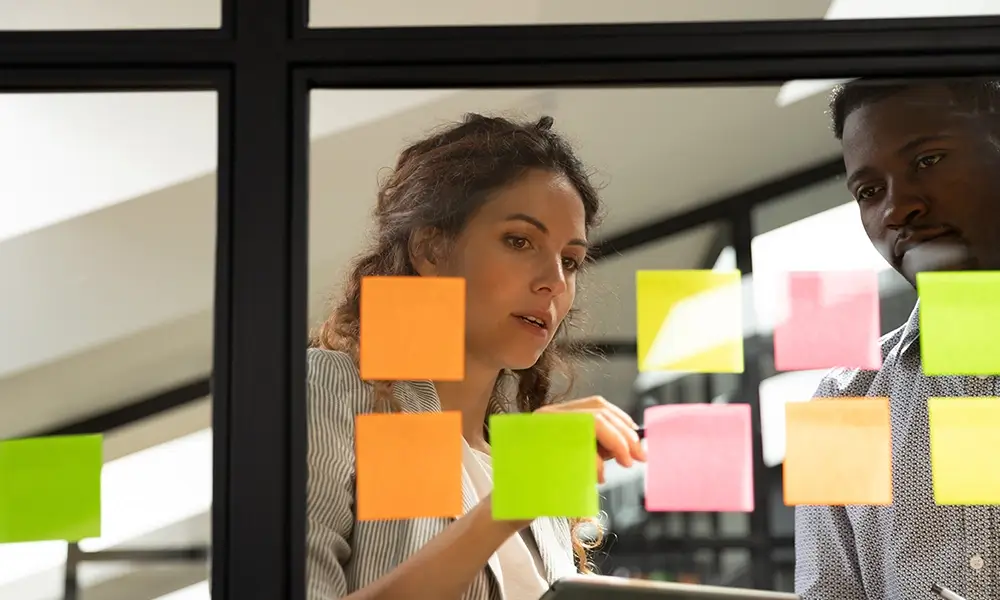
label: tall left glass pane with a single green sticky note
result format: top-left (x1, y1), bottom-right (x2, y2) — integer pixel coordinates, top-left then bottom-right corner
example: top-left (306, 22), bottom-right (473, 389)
top-left (0, 92), bottom-right (218, 600)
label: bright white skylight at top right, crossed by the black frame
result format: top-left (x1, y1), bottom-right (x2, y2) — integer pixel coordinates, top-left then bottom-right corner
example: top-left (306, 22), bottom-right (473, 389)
top-left (776, 0), bottom-right (1000, 106)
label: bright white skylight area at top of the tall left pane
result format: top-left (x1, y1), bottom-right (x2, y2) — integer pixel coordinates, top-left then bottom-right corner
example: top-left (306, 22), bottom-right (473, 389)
top-left (0, 92), bottom-right (219, 241)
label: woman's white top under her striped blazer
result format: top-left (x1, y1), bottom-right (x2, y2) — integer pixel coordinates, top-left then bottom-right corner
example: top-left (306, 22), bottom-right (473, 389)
top-left (462, 439), bottom-right (549, 600)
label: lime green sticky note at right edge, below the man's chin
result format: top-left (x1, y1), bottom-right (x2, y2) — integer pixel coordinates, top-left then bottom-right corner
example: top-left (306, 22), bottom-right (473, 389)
top-left (917, 271), bottom-right (1000, 375)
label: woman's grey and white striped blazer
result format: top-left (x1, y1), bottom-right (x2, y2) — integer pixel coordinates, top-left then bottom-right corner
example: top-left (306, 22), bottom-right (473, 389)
top-left (306, 348), bottom-right (576, 600)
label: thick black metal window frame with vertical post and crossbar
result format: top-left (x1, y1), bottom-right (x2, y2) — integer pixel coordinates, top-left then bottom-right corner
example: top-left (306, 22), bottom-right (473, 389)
top-left (0, 0), bottom-right (1000, 600)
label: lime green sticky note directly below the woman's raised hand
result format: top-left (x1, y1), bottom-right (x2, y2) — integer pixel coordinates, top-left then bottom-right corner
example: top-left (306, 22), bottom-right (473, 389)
top-left (489, 413), bottom-right (599, 520)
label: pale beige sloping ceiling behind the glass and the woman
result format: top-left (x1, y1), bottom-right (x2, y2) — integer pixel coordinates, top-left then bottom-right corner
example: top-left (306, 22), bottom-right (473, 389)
top-left (0, 0), bottom-right (920, 600)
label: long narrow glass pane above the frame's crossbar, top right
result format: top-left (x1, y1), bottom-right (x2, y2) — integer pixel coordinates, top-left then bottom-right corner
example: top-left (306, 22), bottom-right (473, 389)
top-left (309, 0), bottom-right (1000, 27)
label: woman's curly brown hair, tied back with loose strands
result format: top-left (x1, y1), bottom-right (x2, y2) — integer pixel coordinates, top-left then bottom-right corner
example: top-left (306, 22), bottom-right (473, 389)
top-left (311, 114), bottom-right (601, 573)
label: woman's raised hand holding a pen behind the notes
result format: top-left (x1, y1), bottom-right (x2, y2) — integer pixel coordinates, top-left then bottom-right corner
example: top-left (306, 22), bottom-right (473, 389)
top-left (535, 396), bottom-right (646, 483)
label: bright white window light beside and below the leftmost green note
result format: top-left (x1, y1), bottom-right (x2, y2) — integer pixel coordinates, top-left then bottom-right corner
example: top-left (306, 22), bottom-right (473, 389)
top-left (0, 429), bottom-right (212, 596)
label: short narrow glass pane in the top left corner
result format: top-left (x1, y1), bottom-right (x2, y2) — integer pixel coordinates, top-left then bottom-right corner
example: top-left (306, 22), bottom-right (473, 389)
top-left (0, 0), bottom-right (222, 31)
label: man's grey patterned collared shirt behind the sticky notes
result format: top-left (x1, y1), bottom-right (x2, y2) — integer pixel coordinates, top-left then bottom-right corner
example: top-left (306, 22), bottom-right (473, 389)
top-left (795, 303), bottom-right (1000, 600)
